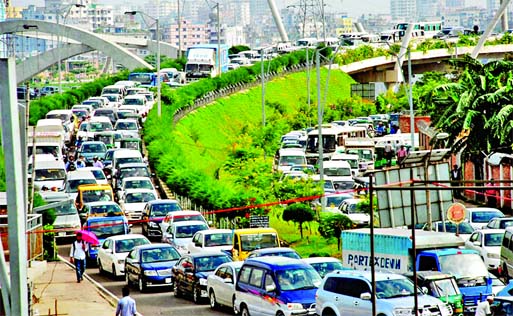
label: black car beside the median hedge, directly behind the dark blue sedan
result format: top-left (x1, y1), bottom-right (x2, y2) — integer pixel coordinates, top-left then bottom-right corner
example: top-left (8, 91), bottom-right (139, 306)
top-left (141, 199), bottom-right (182, 237)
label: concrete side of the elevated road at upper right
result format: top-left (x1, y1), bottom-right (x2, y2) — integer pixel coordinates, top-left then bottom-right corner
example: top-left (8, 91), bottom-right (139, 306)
top-left (337, 44), bottom-right (513, 83)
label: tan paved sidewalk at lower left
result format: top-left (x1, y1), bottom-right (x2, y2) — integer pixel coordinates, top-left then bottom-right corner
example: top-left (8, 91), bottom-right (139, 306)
top-left (32, 261), bottom-right (116, 316)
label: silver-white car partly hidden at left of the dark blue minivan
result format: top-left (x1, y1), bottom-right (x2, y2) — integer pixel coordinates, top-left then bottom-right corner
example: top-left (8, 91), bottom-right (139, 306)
top-left (207, 261), bottom-right (243, 310)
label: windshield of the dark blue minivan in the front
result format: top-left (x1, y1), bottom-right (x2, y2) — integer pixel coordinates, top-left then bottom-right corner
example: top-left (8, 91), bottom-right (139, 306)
top-left (276, 267), bottom-right (322, 291)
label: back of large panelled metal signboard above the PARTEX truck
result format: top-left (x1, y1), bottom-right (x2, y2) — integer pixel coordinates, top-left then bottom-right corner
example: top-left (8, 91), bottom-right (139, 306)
top-left (375, 163), bottom-right (453, 228)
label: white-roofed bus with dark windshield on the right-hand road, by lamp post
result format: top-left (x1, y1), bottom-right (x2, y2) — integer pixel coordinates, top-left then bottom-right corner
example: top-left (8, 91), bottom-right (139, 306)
top-left (306, 124), bottom-right (368, 165)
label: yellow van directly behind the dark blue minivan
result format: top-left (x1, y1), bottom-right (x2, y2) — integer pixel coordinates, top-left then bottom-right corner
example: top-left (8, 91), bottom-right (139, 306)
top-left (232, 228), bottom-right (280, 261)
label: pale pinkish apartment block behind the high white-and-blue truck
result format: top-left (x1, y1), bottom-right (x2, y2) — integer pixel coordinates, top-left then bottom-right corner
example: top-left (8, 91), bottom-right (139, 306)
top-left (162, 20), bottom-right (209, 50)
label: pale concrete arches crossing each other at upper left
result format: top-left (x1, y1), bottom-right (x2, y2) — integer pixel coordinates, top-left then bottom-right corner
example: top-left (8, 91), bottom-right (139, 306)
top-left (0, 19), bottom-right (177, 83)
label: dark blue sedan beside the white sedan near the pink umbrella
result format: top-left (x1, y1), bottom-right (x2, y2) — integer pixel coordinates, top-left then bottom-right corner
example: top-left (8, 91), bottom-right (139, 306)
top-left (125, 243), bottom-right (180, 292)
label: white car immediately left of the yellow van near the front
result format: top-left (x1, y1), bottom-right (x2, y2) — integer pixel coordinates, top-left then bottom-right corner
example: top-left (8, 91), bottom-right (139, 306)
top-left (187, 229), bottom-right (233, 253)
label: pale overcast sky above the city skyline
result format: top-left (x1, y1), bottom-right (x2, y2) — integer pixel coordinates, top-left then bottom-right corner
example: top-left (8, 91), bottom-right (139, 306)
top-left (11, 0), bottom-right (486, 17)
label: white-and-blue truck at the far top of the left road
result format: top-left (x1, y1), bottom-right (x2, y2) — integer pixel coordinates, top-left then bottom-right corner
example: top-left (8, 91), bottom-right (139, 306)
top-left (185, 44), bottom-right (229, 81)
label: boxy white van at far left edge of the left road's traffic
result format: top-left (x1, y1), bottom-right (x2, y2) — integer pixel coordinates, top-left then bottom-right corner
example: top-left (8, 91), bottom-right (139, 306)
top-left (32, 160), bottom-right (66, 190)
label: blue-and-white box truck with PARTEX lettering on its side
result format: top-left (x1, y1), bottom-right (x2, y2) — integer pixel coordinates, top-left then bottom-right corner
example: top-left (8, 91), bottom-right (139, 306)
top-left (341, 228), bottom-right (492, 313)
